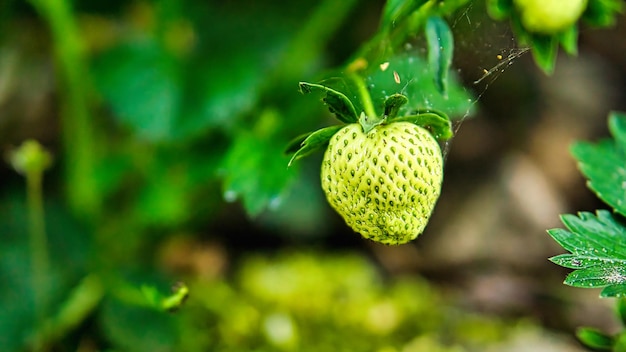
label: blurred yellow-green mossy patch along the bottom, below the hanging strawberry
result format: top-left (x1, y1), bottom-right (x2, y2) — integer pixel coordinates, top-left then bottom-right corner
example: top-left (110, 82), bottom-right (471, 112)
top-left (177, 251), bottom-right (523, 351)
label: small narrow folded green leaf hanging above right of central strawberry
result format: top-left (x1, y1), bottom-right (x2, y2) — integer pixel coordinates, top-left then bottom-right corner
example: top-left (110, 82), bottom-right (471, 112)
top-left (426, 16), bottom-right (454, 96)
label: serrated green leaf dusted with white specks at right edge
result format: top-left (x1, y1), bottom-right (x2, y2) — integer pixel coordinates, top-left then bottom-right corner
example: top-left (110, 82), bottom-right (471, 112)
top-left (548, 210), bottom-right (626, 296)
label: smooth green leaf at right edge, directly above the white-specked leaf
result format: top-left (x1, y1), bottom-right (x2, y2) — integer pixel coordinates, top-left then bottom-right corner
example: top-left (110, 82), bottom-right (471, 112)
top-left (571, 113), bottom-right (626, 215)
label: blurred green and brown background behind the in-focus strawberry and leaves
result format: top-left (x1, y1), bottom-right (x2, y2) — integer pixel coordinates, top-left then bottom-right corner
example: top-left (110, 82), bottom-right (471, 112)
top-left (0, 0), bottom-right (626, 351)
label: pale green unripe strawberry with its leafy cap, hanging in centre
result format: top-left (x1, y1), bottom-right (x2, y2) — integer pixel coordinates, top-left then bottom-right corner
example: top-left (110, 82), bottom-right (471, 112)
top-left (287, 83), bottom-right (452, 244)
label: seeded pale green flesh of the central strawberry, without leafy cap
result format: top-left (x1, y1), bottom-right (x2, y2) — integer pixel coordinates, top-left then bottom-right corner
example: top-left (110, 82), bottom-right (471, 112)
top-left (321, 122), bottom-right (443, 244)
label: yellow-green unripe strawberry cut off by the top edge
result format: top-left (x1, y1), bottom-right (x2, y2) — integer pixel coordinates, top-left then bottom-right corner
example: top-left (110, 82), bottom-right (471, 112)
top-left (514, 0), bottom-right (587, 34)
